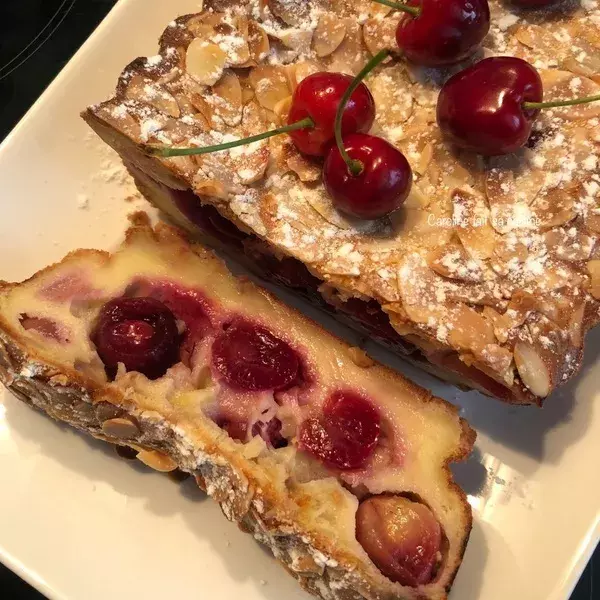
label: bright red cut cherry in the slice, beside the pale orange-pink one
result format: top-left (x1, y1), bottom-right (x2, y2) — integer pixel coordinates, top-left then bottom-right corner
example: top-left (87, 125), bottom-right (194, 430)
top-left (298, 391), bottom-right (381, 470)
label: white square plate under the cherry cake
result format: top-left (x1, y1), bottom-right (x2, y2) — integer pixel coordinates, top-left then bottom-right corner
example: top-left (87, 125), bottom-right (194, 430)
top-left (0, 0), bottom-right (600, 600)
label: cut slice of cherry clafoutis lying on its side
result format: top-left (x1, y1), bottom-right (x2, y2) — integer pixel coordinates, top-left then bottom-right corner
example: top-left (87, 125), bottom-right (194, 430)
top-left (0, 215), bottom-right (475, 600)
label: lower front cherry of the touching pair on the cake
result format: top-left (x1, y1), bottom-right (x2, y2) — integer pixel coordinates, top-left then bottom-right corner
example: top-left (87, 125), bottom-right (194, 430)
top-left (323, 133), bottom-right (412, 219)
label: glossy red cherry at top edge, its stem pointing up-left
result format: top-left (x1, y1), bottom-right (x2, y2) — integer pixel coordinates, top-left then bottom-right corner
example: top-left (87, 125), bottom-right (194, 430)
top-left (396, 0), bottom-right (490, 67)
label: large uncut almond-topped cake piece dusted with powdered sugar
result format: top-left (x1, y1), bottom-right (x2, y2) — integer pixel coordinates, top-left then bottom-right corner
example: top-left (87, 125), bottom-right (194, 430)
top-left (83, 0), bottom-right (600, 404)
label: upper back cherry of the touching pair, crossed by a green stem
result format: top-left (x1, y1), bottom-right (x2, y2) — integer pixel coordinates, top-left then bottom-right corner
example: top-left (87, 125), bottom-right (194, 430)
top-left (288, 73), bottom-right (375, 156)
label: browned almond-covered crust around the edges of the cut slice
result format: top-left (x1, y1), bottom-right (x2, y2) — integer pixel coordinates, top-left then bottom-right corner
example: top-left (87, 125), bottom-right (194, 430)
top-left (0, 215), bottom-right (475, 600)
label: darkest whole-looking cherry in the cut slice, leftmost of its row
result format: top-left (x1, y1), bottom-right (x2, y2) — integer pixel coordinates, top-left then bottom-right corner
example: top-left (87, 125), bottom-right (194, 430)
top-left (92, 298), bottom-right (179, 379)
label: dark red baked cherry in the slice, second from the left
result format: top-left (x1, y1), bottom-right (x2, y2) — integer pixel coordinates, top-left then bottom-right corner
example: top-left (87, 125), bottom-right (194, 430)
top-left (212, 321), bottom-right (300, 392)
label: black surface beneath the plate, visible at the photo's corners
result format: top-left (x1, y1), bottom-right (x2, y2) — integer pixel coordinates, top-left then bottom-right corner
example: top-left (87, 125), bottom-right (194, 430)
top-left (0, 0), bottom-right (600, 600)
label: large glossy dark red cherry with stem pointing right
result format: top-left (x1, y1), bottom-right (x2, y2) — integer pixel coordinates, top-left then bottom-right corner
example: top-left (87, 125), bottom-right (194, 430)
top-left (437, 56), bottom-right (544, 156)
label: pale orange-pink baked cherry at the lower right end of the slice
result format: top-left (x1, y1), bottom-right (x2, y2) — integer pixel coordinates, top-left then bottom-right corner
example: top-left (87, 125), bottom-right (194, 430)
top-left (356, 495), bottom-right (442, 587)
